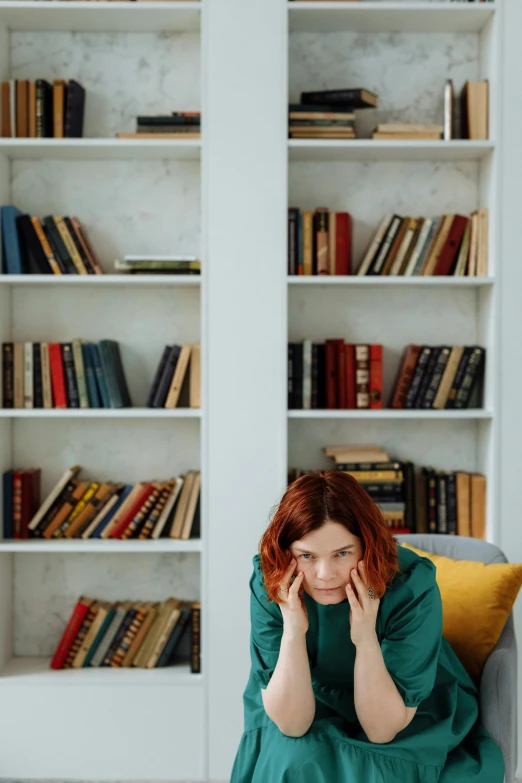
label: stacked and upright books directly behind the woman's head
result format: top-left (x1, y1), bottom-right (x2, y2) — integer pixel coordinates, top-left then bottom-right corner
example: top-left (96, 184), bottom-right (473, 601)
top-left (288, 445), bottom-right (486, 539)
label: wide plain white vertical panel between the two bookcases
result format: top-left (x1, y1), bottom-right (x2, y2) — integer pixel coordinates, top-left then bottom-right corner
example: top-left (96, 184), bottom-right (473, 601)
top-left (204, 0), bottom-right (287, 780)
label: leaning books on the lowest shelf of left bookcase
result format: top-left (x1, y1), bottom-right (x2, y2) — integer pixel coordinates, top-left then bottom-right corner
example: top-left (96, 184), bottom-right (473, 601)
top-left (50, 595), bottom-right (201, 674)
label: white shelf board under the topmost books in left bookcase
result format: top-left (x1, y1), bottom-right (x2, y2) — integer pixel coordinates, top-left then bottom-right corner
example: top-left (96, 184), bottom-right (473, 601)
top-left (0, 138), bottom-right (201, 160)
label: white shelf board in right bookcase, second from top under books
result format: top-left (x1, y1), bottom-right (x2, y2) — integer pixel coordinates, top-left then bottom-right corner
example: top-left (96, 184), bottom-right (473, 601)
top-left (288, 275), bottom-right (495, 288)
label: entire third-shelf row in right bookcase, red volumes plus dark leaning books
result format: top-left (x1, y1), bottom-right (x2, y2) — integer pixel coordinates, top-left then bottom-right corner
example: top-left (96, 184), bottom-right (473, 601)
top-left (288, 338), bottom-right (486, 410)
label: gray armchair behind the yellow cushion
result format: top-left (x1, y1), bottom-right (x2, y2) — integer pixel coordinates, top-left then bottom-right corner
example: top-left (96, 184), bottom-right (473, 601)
top-left (395, 534), bottom-right (517, 783)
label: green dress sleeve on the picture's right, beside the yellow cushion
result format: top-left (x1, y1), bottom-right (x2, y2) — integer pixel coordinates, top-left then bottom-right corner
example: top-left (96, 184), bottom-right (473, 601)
top-left (381, 558), bottom-right (442, 707)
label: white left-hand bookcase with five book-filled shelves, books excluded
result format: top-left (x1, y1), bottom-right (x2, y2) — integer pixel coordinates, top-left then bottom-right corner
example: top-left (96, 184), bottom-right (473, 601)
top-left (0, 0), bottom-right (207, 780)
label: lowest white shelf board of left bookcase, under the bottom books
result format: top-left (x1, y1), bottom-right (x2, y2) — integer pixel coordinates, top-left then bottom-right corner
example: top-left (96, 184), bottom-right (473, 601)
top-left (0, 658), bottom-right (204, 688)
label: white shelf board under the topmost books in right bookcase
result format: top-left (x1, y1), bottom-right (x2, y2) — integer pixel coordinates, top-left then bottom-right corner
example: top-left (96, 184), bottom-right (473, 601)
top-left (288, 139), bottom-right (495, 161)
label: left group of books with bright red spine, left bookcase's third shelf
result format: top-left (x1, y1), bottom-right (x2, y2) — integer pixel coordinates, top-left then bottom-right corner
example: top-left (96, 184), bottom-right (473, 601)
top-left (2, 338), bottom-right (132, 408)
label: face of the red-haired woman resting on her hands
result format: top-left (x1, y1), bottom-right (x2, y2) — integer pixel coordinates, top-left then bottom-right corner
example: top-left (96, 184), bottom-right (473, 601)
top-left (290, 521), bottom-right (363, 604)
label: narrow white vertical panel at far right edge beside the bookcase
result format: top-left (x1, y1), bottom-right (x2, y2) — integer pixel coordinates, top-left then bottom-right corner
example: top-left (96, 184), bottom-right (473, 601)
top-left (499, 0), bottom-right (522, 777)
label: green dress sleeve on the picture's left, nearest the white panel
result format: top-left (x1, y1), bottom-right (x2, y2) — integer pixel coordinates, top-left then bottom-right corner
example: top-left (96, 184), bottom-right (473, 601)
top-left (250, 555), bottom-right (283, 688)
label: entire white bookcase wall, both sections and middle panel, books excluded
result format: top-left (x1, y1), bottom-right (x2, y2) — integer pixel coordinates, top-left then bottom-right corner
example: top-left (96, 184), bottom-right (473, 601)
top-left (0, 0), bottom-right (516, 781)
